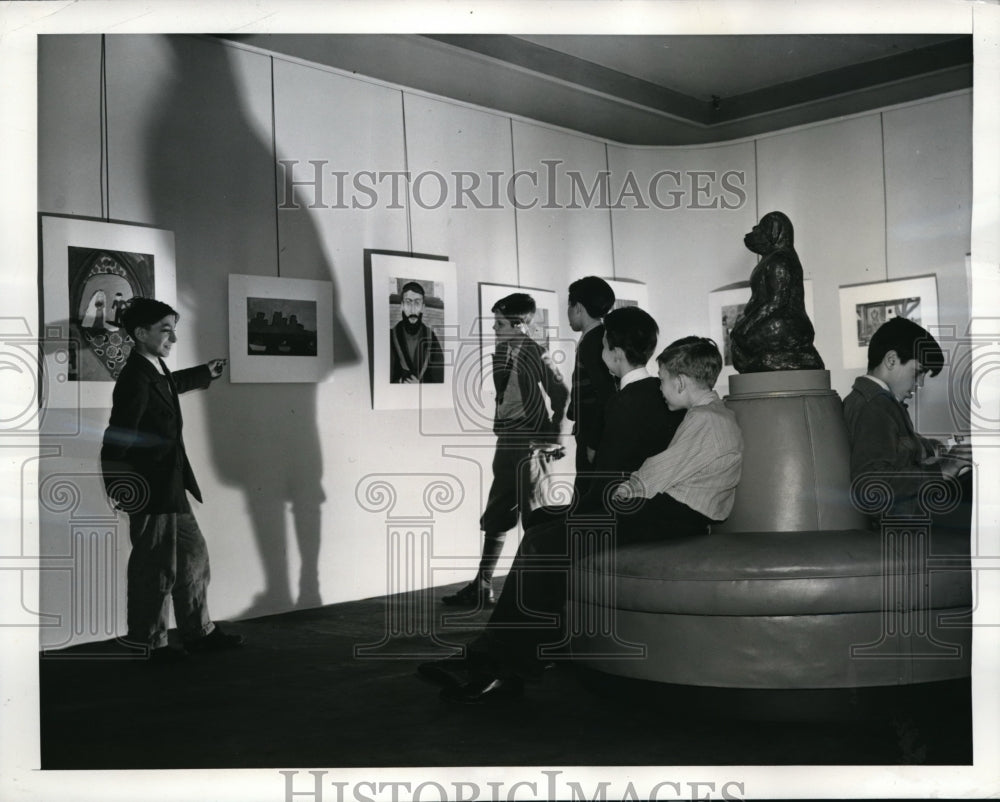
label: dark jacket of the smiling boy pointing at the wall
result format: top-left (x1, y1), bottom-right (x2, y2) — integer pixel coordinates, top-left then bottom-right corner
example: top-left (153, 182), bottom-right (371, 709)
top-left (101, 351), bottom-right (212, 514)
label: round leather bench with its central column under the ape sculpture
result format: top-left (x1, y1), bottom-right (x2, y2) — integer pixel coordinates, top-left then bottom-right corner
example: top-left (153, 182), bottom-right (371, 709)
top-left (572, 371), bottom-right (972, 689)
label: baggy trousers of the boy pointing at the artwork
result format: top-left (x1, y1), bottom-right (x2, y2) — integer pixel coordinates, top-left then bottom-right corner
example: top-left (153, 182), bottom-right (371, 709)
top-left (128, 512), bottom-right (214, 649)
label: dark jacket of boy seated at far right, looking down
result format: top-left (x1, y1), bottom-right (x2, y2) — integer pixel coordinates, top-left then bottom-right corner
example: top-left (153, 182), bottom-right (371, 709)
top-left (844, 376), bottom-right (941, 513)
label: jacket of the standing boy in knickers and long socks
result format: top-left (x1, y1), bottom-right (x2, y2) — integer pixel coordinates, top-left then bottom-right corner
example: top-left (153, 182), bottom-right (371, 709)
top-left (493, 337), bottom-right (569, 439)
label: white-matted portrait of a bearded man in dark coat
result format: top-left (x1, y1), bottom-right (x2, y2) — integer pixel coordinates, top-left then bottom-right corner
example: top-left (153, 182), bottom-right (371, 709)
top-left (369, 251), bottom-right (458, 409)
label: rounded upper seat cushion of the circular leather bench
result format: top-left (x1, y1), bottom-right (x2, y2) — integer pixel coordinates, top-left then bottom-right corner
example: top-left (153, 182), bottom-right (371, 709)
top-left (581, 530), bottom-right (971, 616)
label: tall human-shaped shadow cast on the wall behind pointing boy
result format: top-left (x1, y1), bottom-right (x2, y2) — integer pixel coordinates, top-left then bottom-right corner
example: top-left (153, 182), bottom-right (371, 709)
top-left (146, 37), bottom-right (359, 618)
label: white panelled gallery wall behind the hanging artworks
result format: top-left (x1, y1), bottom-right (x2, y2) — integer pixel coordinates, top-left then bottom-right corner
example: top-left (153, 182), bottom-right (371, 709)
top-left (38, 35), bottom-right (972, 647)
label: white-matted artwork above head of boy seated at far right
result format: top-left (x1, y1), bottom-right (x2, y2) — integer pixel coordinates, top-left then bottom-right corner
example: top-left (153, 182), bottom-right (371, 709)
top-left (840, 275), bottom-right (938, 368)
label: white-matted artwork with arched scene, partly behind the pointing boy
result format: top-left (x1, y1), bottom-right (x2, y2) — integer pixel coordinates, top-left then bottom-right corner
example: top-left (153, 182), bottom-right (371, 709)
top-left (40, 215), bottom-right (180, 409)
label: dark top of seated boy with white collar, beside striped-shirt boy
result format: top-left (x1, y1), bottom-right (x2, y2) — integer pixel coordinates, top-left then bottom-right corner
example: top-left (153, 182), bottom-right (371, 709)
top-left (577, 376), bottom-right (685, 512)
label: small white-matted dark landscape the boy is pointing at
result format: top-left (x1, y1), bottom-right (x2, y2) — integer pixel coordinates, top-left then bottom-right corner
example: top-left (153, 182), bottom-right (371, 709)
top-left (229, 274), bottom-right (333, 383)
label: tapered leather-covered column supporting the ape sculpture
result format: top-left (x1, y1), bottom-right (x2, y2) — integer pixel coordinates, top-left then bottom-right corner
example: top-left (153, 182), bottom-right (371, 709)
top-left (713, 370), bottom-right (868, 532)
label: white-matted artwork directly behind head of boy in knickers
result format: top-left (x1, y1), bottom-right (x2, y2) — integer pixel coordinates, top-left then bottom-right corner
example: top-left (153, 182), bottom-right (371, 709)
top-left (477, 282), bottom-right (576, 410)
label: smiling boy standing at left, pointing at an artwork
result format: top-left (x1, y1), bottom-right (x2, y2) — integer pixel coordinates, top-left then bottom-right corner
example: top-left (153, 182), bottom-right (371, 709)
top-left (101, 298), bottom-right (243, 663)
